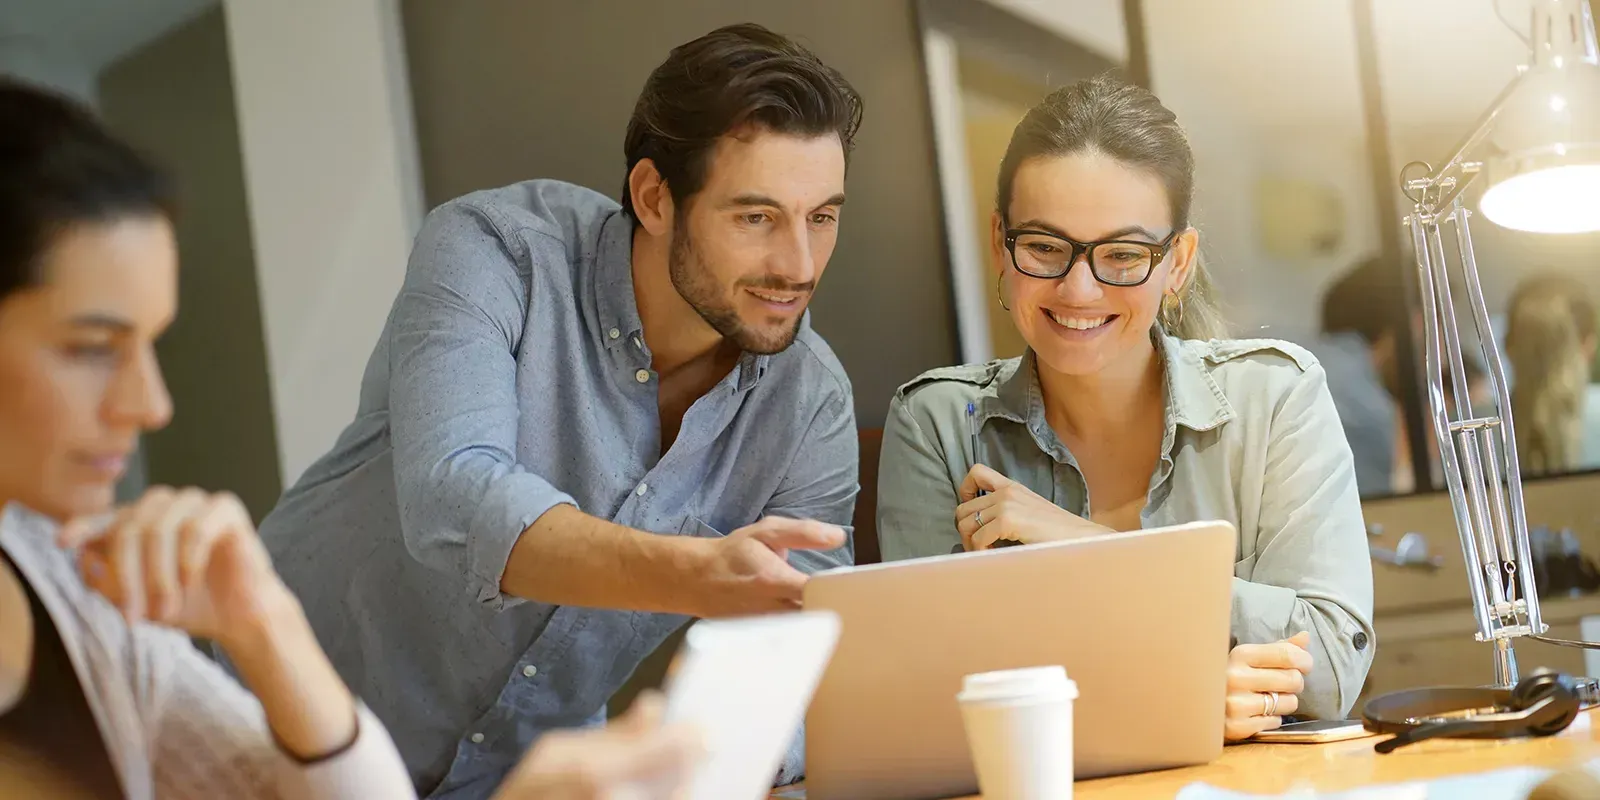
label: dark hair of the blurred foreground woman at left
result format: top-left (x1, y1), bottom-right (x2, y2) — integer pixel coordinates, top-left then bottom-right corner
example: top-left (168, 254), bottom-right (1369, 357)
top-left (0, 77), bottom-right (174, 299)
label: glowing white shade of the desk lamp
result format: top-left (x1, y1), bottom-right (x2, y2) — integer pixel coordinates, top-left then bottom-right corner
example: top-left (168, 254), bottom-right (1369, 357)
top-left (1478, 0), bottom-right (1600, 234)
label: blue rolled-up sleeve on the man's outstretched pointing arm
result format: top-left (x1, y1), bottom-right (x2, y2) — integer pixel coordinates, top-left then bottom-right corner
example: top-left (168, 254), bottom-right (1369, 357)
top-left (389, 202), bottom-right (578, 608)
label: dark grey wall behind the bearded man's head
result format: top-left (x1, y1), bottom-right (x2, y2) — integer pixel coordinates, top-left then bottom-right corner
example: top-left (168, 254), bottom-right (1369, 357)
top-left (402, 0), bottom-right (957, 427)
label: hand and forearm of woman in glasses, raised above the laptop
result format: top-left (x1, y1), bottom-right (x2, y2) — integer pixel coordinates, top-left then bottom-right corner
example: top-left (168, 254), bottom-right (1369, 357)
top-left (955, 464), bottom-right (1112, 550)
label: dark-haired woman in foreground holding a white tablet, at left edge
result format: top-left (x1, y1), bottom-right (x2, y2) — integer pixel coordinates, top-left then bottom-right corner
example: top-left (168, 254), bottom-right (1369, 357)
top-left (0, 80), bottom-right (691, 800)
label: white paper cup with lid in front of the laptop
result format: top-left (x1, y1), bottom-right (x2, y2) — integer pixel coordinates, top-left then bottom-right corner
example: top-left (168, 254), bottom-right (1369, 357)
top-left (955, 666), bottom-right (1078, 800)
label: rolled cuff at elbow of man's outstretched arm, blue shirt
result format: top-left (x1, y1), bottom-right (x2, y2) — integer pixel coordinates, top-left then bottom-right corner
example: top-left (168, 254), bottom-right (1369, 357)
top-left (467, 472), bottom-right (578, 611)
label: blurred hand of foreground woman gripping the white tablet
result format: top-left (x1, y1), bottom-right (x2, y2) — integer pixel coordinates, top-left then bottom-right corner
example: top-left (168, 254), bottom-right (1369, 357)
top-left (494, 693), bottom-right (699, 800)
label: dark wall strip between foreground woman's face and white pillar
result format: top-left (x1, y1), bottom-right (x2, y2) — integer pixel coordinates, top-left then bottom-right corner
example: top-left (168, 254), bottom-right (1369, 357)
top-left (99, 10), bottom-right (282, 520)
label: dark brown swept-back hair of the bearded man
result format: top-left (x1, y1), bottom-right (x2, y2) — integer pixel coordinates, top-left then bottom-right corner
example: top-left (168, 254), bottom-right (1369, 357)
top-left (622, 24), bottom-right (862, 219)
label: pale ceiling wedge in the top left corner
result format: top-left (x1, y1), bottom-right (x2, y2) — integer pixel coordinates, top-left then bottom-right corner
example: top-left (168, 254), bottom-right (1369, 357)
top-left (0, 0), bottom-right (218, 72)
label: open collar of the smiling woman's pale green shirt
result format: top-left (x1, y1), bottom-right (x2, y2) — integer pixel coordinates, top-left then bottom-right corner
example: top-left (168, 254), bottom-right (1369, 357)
top-left (976, 328), bottom-right (1234, 453)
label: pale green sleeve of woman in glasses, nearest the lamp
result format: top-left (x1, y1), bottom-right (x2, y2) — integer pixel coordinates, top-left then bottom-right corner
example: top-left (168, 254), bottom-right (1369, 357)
top-left (1232, 363), bottom-right (1376, 718)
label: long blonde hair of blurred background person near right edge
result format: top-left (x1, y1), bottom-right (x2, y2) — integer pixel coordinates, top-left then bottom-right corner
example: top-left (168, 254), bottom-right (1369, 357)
top-left (1506, 275), bottom-right (1595, 475)
